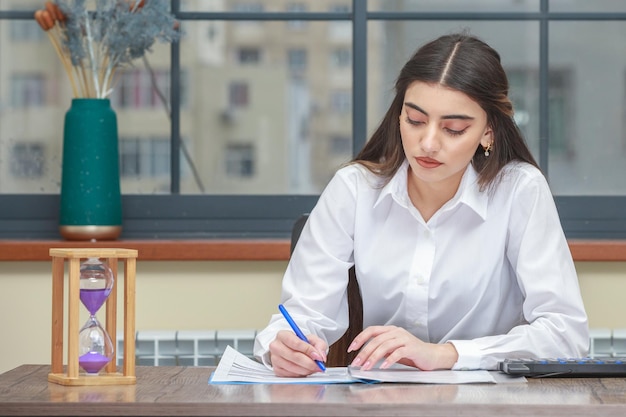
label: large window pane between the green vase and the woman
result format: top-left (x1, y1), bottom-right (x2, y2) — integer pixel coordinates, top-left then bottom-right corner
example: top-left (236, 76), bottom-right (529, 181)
top-left (180, 18), bottom-right (352, 194)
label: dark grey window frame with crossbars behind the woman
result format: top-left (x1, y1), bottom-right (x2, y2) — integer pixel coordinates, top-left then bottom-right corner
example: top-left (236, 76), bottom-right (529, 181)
top-left (0, 0), bottom-right (626, 239)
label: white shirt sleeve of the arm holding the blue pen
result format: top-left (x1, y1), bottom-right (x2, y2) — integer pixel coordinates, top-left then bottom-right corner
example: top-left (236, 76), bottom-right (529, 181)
top-left (254, 169), bottom-right (357, 367)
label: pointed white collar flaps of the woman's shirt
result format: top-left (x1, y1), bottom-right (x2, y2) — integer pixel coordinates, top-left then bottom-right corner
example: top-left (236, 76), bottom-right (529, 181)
top-left (374, 161), bottom-right (489, 220)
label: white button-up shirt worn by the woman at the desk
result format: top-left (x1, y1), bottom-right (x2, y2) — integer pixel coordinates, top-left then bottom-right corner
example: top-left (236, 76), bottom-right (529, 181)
top-left (254, 162), bottom-right (589, 369)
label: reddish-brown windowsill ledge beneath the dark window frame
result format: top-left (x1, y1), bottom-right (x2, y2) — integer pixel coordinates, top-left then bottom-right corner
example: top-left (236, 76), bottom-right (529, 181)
top-left (0, 239), bottom-right (626, 262)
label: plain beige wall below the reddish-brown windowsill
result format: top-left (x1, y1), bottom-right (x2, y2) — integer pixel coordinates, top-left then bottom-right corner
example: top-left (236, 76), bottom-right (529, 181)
top-left (0, 261), bottom-right (626, 373)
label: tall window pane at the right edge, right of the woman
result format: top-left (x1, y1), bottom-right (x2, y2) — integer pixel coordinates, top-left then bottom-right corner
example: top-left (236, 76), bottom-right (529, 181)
top-left (548, 22), bottom-right (626, 195)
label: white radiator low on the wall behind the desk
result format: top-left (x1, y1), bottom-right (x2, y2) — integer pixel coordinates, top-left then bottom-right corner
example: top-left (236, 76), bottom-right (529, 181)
top-left (117, 328), bottom-right (626, 366)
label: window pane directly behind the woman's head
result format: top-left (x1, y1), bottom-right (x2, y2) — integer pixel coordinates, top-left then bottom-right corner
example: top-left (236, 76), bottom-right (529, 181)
top-left (367, 20), bottom-right (540, 159)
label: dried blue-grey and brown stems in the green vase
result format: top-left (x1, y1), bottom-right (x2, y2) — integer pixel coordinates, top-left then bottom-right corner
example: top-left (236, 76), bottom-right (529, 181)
top-left (35, 0), bottom-right (180, 98)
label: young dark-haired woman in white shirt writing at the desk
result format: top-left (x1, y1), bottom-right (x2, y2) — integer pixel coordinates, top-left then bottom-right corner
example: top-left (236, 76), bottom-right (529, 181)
top-left (255, 34), bottom-right (589, 376)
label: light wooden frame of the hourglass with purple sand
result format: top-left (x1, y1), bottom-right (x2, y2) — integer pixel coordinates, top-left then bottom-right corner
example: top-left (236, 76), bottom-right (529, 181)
top-left (48, 248), bottom-right (137, 385)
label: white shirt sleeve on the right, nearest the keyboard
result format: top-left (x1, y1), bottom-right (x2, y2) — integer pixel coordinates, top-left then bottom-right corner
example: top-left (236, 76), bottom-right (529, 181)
top-left (450, 173), bottom-right (589, 369)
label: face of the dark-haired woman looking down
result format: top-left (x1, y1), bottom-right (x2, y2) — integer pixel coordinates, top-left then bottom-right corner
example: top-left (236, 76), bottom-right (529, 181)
top-left (400, 81), bottom-right (493, 192)
